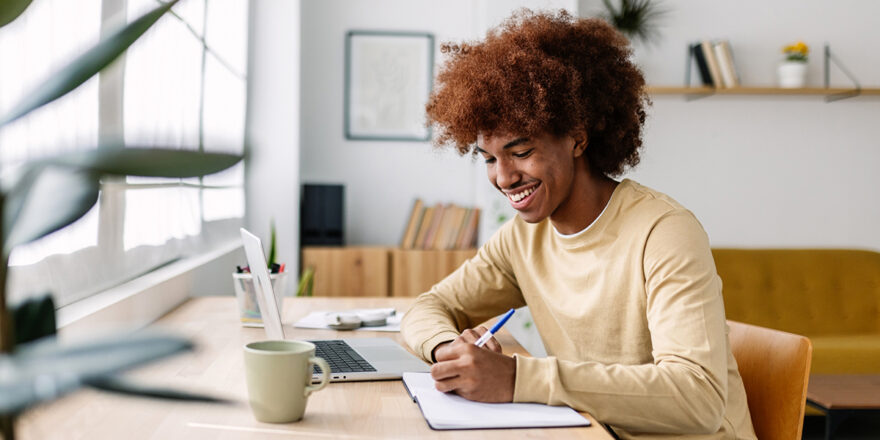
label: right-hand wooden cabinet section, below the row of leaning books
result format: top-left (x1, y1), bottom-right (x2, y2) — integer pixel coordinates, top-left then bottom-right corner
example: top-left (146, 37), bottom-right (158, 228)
top-left (391, 249), bottom-right (477, 296)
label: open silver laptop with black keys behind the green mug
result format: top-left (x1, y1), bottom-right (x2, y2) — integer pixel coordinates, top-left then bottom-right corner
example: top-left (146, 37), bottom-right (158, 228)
top-left (241, 228), bottom-right (430, 382)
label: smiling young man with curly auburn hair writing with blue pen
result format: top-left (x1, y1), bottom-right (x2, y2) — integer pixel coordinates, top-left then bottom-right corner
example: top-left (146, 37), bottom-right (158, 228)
top-left (403, 11), bottom-right (755, 438)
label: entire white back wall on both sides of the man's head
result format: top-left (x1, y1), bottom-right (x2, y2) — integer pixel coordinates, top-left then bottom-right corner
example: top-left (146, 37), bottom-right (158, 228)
top-left (290, 0), bottom-right (880, 249)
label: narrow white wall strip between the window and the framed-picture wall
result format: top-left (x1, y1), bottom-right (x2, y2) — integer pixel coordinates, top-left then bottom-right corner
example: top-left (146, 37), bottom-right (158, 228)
top-left (246, 0), bottom-right (300, 293)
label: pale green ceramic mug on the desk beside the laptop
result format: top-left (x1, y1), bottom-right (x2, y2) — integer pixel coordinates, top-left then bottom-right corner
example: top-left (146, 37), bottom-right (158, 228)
top-left (244, 341), bottom-right (330, 423)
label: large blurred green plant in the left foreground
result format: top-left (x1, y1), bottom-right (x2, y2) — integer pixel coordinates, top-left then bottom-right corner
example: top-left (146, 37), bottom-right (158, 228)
top-left (0, 0), bottom-right (241, 440)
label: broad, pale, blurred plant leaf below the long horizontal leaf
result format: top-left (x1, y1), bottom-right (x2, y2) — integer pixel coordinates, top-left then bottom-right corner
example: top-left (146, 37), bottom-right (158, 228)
top-left (3, 164), bottom-right (100, 255)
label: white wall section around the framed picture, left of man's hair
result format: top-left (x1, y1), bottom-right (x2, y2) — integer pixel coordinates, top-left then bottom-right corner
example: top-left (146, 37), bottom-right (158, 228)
top-left (300, 0), bottom-right (577, 245)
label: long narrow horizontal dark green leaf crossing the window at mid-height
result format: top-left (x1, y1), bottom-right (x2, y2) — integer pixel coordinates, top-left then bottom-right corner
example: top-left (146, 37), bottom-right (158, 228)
top-left (42, 148), bottom-right (242, 177)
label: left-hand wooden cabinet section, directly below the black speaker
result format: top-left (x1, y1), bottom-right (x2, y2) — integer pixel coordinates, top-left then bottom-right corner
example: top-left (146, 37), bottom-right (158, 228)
top-left (302, 247), bottom-right (390, 296)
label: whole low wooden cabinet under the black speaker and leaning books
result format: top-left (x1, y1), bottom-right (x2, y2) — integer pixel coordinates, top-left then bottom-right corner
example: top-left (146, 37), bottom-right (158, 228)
top-left (302, 246), bottom-right (477, 296)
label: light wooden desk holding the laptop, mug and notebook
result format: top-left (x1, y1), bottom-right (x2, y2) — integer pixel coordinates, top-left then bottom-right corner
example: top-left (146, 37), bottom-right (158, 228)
top-left (18, 297), bottom-right (611, 440)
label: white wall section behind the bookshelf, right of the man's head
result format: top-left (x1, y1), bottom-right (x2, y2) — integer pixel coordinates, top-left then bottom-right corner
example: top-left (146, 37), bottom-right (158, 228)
top-left (580, 0), bottom-right (880, 250)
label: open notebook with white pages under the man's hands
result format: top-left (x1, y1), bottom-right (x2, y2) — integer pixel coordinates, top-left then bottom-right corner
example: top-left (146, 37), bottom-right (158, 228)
top-left (403, 373), bottom-right (590, 430)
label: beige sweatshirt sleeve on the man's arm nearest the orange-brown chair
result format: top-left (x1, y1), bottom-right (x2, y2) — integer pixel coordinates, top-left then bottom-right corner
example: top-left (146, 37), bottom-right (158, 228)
top-left (514, 209), bottom-right (729, 434)
